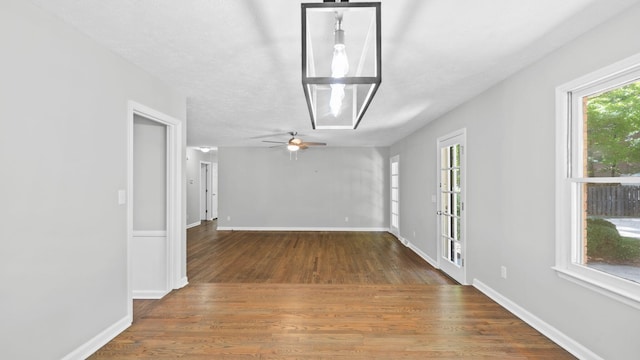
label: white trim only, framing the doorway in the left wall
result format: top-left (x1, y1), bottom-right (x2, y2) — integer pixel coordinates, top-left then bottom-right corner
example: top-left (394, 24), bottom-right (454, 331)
top-left (127, 101), bottom-right (187, 320)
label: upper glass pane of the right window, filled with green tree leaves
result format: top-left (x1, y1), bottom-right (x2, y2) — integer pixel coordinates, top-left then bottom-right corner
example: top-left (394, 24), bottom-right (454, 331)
top-left (582, 81), bottom-right (640, 177)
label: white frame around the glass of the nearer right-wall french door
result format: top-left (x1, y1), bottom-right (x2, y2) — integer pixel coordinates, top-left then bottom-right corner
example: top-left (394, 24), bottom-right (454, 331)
top-left (436, 128), bottom-right (469, 285)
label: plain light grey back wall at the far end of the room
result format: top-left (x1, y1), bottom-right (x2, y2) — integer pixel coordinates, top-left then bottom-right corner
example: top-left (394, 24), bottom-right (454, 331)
top-left (218, 147), bottom-right (389, 230)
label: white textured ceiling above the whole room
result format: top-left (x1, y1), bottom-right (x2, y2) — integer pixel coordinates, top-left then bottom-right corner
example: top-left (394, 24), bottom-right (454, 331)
top-left (32, 0), bottom-right (638, 146)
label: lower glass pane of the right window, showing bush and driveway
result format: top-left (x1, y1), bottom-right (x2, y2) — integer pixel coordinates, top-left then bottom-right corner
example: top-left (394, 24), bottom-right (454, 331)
top-left (579, 184), bottom-right (640, 282)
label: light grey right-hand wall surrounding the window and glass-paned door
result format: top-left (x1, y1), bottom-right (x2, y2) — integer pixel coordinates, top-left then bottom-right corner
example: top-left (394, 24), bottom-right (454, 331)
top-left (390, 6), bottom-right (640, 359)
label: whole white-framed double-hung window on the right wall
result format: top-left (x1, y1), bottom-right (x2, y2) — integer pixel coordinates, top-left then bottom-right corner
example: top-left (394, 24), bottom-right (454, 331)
top-left (555, 56), bottom-right (640, 308)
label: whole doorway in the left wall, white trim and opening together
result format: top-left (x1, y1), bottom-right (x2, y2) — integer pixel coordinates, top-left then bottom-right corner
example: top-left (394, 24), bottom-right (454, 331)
top-left (127, 101), bottom-right (187, 320)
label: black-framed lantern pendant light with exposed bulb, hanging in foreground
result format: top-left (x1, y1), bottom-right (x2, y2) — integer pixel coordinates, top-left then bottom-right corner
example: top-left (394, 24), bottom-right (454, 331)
top-left (301, 0), bottom-right (382, 129)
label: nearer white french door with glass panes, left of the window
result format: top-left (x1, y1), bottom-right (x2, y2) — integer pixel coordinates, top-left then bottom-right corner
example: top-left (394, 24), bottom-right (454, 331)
top-left (437, 129), bottom-right (467, 284)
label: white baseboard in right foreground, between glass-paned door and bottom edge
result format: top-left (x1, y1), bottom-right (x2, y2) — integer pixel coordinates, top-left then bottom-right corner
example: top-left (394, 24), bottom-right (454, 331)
top-left (473, 279), bottom-right (604, 360)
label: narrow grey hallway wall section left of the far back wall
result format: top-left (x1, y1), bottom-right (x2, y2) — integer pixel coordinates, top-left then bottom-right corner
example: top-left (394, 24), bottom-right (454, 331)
top-left (186, 148), bottom-right (218, 226)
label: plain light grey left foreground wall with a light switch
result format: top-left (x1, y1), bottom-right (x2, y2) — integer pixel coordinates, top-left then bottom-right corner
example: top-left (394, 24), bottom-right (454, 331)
top-left (0, 0), bottom-right (186, 359)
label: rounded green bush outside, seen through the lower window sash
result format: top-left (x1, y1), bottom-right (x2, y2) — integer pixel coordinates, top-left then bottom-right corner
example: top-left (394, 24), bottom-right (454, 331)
top-left (587, 218), bottom-right (640, 263)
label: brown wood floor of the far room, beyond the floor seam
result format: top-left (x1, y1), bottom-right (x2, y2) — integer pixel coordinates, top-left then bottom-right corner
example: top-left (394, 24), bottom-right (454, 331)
top-left (187, 222), bottom-right (455, 284)
